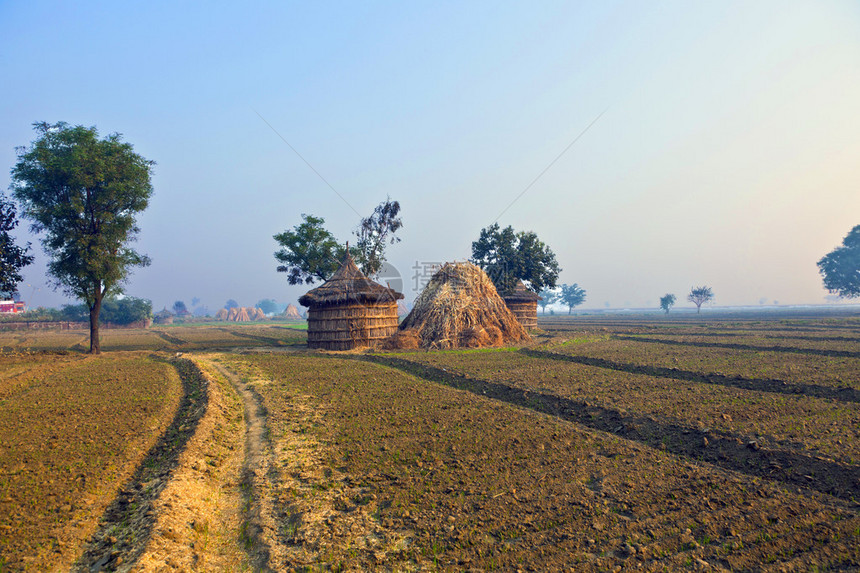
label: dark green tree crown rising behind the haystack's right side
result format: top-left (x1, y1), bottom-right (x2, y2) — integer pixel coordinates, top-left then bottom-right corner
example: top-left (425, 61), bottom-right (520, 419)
top-left (471, 223), bottom-right (561, 294)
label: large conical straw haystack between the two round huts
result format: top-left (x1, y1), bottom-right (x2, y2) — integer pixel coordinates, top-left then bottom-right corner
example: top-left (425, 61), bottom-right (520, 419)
top-left (386, 263), bottom-right (529, 349)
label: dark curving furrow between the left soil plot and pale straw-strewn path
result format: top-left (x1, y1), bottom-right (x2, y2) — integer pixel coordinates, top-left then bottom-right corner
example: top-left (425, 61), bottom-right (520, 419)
top-left (72, 359), bottom-right (208, 573)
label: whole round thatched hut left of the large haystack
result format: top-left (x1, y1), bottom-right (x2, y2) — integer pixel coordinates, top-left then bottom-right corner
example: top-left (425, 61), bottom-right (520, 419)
top-left (299, 253), bottom-right (403, 350)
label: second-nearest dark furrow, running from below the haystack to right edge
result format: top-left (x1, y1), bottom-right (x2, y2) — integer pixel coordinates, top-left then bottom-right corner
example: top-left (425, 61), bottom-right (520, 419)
top-left (519, 348), bottom-right (860, 402)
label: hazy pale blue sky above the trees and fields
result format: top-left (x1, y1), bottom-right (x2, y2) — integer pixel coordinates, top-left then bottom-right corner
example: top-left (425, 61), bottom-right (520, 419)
top-left (0, 0), bottom-right (860, 313)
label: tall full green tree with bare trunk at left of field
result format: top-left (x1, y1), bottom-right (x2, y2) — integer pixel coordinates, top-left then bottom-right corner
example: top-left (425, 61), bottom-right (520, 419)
top-left (11, 122), bottom-right (155, 354)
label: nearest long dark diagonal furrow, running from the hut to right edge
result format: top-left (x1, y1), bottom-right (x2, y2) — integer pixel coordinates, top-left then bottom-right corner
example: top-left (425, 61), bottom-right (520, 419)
top-left (356, 354), bottom-right (860, 510)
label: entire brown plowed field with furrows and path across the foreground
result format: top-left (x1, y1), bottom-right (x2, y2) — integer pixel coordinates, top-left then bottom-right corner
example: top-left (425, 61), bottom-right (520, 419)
top-left (0, 315), bottom-right (860, 571)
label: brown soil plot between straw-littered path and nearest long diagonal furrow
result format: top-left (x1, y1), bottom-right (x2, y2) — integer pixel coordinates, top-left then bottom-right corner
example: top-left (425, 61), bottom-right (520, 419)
top-left (241, 353), bottom-right (860, 571)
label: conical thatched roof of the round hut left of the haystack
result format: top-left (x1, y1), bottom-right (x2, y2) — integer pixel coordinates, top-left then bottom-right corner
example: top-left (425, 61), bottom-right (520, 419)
top-left (299, 251), bottom-right (403, 307)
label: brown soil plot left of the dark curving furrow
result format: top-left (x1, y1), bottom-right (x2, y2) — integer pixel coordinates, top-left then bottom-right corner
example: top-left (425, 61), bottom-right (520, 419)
top-left (0, 354), bottom-right (180, 571)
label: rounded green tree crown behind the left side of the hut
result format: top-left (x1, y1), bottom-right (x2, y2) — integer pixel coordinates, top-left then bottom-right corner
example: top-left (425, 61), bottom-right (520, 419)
top-left (274, 213), bottom-right (345, 285)
